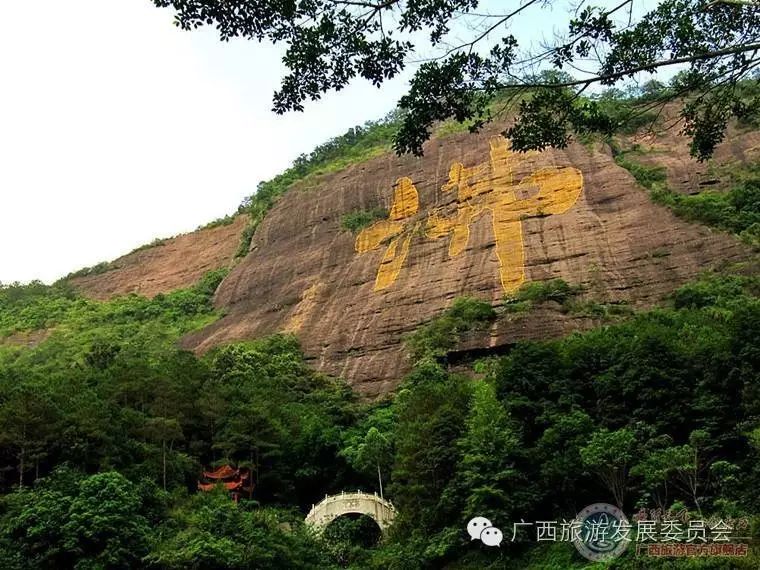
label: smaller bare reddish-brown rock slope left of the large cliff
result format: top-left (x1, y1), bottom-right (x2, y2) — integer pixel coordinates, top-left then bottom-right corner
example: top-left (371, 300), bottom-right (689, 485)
top-left (71, 216), bottom-right (248, 299)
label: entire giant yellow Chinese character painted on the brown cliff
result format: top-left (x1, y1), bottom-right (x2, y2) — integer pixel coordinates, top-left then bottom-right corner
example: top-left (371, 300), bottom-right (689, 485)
top-left (355, 137), bottom-right (583, 292)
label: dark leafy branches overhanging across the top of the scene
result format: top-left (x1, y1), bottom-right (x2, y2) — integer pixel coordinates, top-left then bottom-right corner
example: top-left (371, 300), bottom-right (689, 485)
top-left (153, 0), bottom-right (760, 160)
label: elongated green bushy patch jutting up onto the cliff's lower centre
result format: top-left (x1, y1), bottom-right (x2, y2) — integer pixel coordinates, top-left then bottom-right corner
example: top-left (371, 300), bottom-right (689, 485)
top-left (404, 297), bottom-right (496, 362)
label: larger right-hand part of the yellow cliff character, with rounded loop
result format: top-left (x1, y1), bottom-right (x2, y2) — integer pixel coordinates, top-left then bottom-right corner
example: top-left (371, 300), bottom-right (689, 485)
top-left (425, 137), bottom-right (583, 292)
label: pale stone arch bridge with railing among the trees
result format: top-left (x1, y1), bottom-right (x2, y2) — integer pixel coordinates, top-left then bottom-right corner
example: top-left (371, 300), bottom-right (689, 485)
top-left (306, 491), bottom-right (396, 534)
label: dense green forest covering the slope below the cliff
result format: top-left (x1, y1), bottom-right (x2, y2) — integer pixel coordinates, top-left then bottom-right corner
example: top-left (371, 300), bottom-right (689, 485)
top-left (0, 258), bottom-right (760, 568)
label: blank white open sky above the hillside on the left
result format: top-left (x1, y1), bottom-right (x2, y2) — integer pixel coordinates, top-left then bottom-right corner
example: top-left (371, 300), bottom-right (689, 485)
top-left (0, 0), bottom-right (660, 283)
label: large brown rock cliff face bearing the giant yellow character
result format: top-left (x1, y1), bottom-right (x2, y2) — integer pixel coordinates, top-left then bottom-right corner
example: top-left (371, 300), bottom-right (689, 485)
top-left (180, 127), bottom-right (757, 397)
